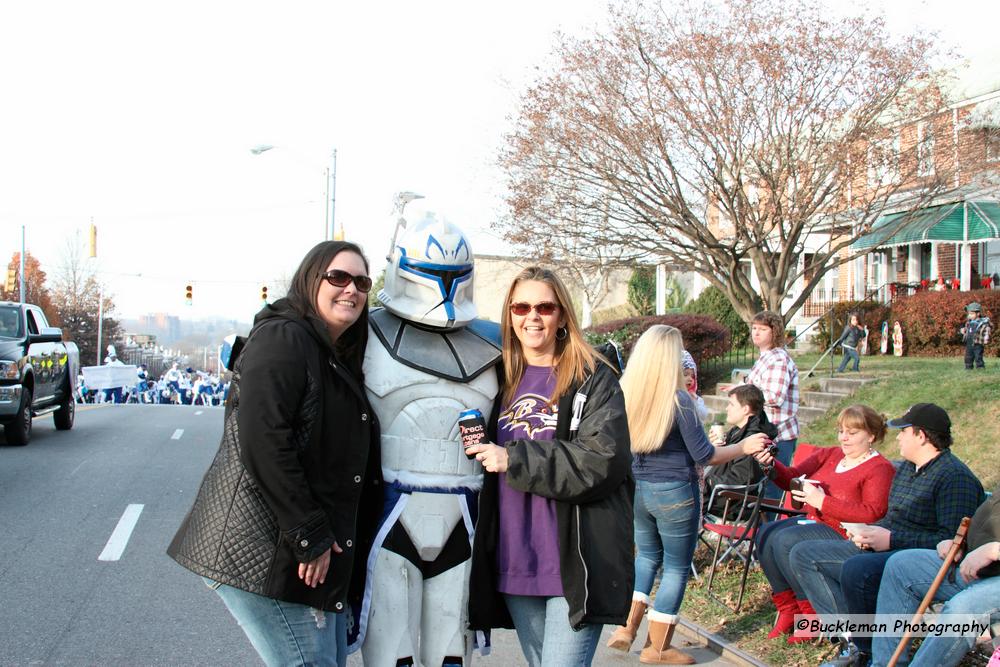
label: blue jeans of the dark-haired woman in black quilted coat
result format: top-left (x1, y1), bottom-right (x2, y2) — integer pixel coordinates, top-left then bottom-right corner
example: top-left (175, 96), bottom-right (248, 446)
top-left (204, 579), bottom-right (347, 667)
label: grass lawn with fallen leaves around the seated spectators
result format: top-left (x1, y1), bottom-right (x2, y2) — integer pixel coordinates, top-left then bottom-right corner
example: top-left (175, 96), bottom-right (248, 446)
top-left (681, 354), bottom-right (1000, 667)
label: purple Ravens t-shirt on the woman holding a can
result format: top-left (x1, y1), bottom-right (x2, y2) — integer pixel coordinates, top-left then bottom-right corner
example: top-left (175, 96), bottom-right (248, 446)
top-left (497, 366), bottom-right (563, 597)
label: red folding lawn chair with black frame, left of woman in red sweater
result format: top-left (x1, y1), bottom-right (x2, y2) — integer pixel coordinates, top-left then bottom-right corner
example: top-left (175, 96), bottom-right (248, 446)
top-left (704, 443), bottom-right (817, 613)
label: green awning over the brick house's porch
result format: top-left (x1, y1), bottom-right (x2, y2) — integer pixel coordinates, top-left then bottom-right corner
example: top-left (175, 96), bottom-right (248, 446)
top-left (851, 201), bottom-right (1000, 250)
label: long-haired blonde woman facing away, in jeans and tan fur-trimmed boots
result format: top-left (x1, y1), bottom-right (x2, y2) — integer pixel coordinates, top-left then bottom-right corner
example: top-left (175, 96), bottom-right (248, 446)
top-left (608, 324), bottom-right (768, 665)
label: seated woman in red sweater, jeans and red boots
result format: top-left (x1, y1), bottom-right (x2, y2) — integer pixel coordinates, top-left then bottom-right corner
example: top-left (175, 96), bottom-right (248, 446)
top-left (756, 405), bottom-right (896, 643)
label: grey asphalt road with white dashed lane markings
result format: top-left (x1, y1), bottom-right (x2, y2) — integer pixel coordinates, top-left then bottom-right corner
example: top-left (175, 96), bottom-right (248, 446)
top-left (0, 405), bottom-right (726, 667)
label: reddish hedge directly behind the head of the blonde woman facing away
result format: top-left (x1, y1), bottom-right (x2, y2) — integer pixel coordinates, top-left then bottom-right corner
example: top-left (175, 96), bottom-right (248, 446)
top-left (584, 314), bottom-right (731, 366)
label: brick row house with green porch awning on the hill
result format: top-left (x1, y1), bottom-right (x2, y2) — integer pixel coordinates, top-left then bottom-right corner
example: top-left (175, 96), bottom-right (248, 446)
top-left (837, 71), bottom-right (1000, 310)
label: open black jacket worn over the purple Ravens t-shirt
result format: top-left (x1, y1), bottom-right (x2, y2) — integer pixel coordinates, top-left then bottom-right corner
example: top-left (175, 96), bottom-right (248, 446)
top-left (469, 363), bottom-right (635, 630)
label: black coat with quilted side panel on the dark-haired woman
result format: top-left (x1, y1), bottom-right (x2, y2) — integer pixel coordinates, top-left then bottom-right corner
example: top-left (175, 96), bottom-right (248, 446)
top-left (167, 301), bottom-right (382, 612)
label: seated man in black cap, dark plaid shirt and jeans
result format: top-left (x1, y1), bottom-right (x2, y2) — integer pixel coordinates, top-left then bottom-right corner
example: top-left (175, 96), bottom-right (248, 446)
top-left (790, 403), bottom-right (985, 665)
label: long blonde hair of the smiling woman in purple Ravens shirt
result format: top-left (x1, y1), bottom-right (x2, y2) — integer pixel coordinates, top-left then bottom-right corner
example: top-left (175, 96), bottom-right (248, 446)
top-left (500, 266), bottom-right (597, 405)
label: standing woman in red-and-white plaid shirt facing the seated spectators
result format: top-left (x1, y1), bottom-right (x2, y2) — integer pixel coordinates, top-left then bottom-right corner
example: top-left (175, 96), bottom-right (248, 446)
top-left (747, 310), bottom-right (799, 498)
